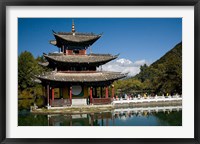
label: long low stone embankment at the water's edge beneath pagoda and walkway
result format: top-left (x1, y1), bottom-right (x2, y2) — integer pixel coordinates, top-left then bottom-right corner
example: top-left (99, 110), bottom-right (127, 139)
top-left (30, 100), bottom-right (182, 114)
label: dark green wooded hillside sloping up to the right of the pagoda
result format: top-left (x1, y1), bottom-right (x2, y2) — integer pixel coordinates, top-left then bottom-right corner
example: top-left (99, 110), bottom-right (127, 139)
top-left (116, 42), bottom-right (182, 94)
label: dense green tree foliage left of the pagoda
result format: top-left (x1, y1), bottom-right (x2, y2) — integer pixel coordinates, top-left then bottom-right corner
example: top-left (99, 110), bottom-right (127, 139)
top-left (18, 51), bottom-right (49, 109)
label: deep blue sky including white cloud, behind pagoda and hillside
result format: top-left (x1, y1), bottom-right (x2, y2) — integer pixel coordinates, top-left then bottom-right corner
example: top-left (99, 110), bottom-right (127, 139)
top-left (18, 18), bottom-right (182, 76)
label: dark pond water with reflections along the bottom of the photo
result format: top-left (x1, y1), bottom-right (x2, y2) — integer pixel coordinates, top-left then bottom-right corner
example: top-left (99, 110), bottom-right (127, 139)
top-left (18, 107), bottom-right (182, 126)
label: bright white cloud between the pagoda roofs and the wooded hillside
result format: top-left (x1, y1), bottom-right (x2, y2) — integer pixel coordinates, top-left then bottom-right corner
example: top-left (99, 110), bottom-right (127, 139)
top-left (98, 58), bottom-right (149, 76)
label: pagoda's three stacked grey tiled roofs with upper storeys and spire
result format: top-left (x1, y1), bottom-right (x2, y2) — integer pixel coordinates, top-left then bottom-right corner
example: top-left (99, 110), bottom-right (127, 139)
top-left (38, 20), bottom-right (126, 83)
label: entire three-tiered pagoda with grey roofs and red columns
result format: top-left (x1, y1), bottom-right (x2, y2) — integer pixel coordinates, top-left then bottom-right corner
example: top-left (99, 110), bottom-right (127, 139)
top-left (38, 20), bottom-right (126, 106)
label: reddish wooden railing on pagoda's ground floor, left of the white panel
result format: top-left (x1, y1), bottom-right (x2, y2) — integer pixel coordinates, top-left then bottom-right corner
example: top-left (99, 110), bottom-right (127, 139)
top-left (50, 99), bottom-right (71, 107)
